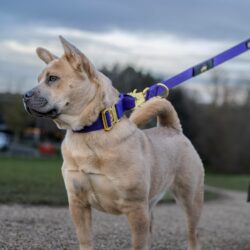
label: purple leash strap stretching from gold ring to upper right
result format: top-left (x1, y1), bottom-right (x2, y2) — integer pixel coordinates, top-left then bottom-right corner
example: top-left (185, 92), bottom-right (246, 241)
top-left (145, 39), bottom-right (250, 101)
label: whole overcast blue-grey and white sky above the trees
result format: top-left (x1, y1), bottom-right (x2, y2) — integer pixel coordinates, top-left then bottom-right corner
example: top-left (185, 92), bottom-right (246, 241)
top-left (0, 0), bottom-right (250, 92)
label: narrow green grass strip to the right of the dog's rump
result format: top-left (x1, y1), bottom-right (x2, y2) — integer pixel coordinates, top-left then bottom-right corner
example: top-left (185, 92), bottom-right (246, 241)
top-left (205, 173), bottom-right (250, 191)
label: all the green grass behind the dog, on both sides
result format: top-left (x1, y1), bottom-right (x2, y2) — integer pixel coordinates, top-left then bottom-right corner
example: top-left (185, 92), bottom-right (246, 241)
top-left (0, 157), bottom-right (250, 206)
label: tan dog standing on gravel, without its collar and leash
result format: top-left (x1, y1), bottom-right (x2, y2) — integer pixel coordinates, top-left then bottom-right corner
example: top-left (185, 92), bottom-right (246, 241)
top-left (24, 37), bottom-right (204, 250)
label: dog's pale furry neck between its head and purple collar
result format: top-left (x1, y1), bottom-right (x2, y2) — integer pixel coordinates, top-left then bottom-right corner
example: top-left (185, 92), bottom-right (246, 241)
top-left (54, 73), bottom-right (119, 131)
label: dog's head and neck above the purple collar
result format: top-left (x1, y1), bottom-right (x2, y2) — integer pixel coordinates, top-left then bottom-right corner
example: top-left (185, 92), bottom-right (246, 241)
top-left (23, 37), bottom-right (117, 129)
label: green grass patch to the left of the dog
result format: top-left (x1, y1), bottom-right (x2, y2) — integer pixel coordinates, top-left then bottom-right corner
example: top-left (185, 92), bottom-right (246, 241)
top-left (0, 157), bottom-right (67, 205)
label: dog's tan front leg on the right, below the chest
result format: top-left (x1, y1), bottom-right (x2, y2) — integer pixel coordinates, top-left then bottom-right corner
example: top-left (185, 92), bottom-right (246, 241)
top-left (128, 207), bottom-right (150, 250)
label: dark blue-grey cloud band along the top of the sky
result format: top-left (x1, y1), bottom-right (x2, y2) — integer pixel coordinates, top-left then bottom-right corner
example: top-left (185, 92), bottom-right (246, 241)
top-left (0, 0), bottom-right (250, 40)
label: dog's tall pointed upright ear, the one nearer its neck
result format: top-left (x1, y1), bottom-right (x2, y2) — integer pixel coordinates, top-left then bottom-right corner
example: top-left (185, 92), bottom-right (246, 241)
top-left (59, 36), bottom-right (96, 78)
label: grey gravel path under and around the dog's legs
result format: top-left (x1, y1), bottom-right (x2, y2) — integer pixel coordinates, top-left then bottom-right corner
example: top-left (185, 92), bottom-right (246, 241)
top-left (0, 189), bottom-right (250, 250)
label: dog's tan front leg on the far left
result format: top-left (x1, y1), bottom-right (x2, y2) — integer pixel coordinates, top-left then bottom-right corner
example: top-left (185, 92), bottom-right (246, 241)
top-left (69, 198), bottom-right (92, 250)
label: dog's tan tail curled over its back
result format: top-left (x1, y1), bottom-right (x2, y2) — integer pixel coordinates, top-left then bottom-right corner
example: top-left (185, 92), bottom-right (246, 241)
top-left (129, 97), bottom-right (182, 132)
